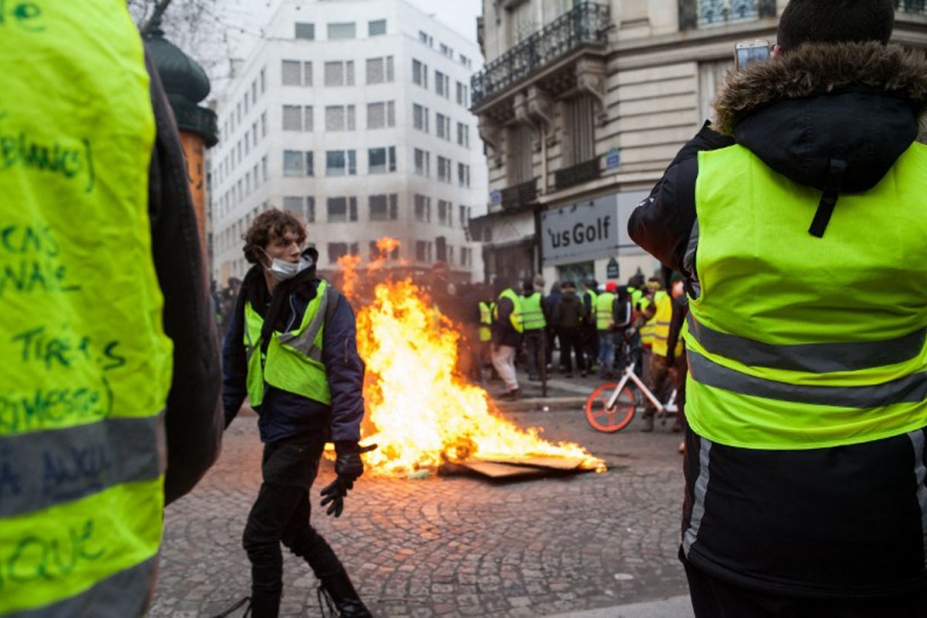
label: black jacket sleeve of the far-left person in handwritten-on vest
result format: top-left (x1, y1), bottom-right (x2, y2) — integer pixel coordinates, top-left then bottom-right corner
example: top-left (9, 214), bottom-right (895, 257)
top-left (145, 55), bottom-right (222, 504)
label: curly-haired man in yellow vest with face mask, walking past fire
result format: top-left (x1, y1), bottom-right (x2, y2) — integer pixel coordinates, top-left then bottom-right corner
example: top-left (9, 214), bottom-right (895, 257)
top-left (223, 208), bottom-right (370, 618)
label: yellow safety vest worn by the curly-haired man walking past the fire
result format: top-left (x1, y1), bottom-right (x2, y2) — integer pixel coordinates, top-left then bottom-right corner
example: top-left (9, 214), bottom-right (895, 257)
top-left (245, 281), bottom-right (338, 406)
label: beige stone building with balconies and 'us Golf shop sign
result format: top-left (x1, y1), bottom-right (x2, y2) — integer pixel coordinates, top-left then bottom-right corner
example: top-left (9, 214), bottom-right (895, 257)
top-left (471, 0), bottom-right (927, 282)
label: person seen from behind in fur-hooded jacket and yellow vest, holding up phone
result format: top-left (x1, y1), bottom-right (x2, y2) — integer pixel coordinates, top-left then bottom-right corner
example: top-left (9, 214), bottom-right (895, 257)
top-left (629, 0), bottom-right (927, 618)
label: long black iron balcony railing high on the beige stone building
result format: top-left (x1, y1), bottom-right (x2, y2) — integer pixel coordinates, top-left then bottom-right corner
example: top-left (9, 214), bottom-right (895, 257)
top-left (470, 2), bottom-right (608, 107)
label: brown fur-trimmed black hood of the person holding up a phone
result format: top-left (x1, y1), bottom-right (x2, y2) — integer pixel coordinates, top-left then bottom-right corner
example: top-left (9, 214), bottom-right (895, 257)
top-left (714, 42), bottom-right (927, 192)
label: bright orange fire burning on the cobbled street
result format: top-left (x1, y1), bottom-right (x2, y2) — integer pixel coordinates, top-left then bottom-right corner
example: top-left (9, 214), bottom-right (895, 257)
top-left (339, 238), bottom-right (604, 475)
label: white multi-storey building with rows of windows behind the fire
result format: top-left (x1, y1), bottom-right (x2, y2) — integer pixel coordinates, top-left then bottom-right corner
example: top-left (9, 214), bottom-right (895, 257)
top-left (210, 0), bottom-right (487, 282)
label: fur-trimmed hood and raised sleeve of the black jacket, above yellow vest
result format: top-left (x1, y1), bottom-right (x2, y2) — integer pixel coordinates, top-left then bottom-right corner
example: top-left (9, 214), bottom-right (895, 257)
top-left (628, 43), bottom-right (927, 277)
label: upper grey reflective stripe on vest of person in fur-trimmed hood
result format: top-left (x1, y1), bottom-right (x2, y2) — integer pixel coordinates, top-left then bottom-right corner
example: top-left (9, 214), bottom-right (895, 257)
top-left (686, 312), bottom-right (927, 373)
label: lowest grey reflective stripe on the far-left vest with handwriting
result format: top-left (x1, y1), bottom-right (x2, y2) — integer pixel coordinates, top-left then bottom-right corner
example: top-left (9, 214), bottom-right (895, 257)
top-left (4, 556), bottom-right (158, 618)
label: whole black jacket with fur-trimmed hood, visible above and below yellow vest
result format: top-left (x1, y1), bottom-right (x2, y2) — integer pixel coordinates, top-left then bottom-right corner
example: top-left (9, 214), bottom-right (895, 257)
top-left (629, 43), bottom-right (927, 596)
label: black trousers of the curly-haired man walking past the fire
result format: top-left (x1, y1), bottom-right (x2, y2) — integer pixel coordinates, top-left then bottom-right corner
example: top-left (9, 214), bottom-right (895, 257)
top-left (242, 437), bottom-right (344, 599)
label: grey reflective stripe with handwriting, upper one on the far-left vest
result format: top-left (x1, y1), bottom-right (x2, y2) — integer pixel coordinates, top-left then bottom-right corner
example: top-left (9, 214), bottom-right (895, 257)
top-left (0, 412), bottom-right (167, 518)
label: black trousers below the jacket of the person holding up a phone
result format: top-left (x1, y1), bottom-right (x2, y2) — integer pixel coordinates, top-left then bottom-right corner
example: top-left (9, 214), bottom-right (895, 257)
top-left (680, 555), bottom-right (927, 618)
